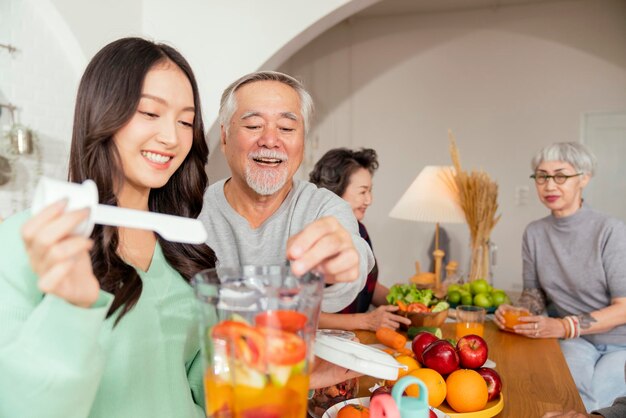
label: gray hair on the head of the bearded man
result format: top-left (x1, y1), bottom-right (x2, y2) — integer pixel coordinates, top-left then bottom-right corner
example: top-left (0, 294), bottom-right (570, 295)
top-left (219, 71), bottom-right (313, 137)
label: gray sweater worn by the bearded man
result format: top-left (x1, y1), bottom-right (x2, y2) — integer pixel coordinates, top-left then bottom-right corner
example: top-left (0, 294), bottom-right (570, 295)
top-left (199, 180), bottom-right (374, 312)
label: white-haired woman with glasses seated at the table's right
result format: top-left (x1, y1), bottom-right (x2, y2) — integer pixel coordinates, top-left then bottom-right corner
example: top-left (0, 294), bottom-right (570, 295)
top-left (495, 142), bottom-right (626, 411)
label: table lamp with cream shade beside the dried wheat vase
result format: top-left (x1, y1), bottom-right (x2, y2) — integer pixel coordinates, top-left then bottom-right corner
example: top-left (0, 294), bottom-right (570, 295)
top-left (389, 165), bottom-right (465, 289)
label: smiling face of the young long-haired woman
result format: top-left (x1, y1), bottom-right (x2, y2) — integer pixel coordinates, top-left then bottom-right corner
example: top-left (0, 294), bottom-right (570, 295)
top-left (113, 61), bottom-right (195, 201)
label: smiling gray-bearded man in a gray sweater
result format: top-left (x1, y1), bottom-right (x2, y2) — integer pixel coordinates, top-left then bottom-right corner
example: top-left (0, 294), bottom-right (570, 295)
top-left (200, 71), bottom-right (374, 312)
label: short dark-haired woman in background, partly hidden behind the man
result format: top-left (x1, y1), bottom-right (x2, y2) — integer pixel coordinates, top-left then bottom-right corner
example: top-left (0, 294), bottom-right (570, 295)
top-left (309, 148), bottom-right (411, 331)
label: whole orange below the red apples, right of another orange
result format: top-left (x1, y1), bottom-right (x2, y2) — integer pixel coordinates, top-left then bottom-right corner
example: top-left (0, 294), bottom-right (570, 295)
top-left (446, 369), bottom-right (488, 412)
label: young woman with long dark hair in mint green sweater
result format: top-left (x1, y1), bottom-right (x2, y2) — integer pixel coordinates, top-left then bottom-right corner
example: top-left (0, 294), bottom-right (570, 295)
top-left (0, 38), bottom-right (215, 418)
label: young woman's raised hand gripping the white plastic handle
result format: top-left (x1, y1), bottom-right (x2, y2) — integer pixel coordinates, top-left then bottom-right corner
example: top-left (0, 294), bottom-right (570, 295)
top-left (22, 201), bottom-right (100, 308)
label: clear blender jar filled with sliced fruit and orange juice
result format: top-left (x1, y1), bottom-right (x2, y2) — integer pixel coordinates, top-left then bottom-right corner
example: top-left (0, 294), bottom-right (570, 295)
top-left (193, 266), bottom-right (323, 418)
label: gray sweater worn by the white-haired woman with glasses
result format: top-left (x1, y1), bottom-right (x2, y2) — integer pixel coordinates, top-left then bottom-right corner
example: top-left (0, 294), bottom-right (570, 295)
top-left (522, 205), bottom-right (626, 345)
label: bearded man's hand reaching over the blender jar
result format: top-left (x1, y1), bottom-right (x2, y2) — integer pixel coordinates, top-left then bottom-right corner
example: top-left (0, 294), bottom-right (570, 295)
top-left (287, 216), bottom-right (359, 283)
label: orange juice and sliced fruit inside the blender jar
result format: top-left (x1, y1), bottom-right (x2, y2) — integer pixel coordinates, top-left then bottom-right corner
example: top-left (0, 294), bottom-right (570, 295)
top-left (204, 318), bottom-right (309, 418)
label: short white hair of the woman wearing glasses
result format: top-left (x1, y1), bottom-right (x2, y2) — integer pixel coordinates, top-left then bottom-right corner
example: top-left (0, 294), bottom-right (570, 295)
top-left (530, 142), bottom-right (596, 176)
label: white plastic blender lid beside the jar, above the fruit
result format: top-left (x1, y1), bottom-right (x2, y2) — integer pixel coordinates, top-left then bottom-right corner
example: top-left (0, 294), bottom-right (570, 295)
top-left (314, 333), bottom-right (408, 380)
